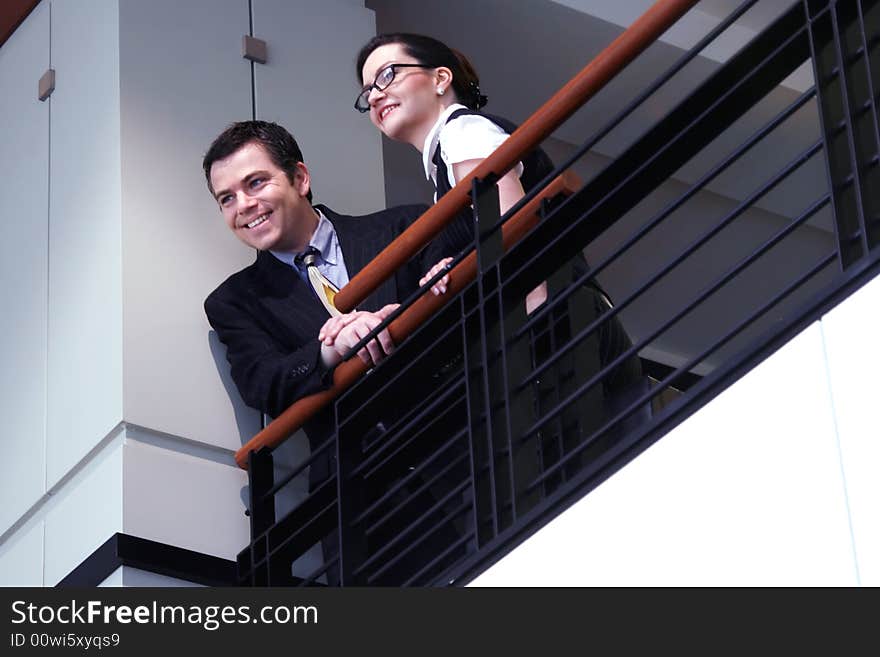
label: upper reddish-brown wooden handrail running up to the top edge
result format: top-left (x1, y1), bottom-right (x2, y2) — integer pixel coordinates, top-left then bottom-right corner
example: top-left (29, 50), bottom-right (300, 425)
top-left (334, 0), bottom-right (697, 312)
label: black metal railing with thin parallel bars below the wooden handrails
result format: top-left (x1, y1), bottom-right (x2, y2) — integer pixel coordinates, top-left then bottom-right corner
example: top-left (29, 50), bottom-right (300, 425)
top-left (239, 0), bottom-right (880, 585)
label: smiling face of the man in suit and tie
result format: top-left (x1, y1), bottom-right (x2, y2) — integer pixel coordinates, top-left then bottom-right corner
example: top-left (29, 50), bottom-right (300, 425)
top-left (211, 142), bottom-right (318, 252)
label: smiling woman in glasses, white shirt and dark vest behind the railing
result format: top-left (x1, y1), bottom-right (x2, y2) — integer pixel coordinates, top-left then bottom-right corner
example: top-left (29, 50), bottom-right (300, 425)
top-left (355, 33), bottom-right (641, 462)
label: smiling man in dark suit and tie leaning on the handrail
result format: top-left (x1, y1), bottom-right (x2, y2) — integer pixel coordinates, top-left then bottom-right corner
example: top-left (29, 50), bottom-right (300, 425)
top-left (203, 121), bottom-right (425, 422)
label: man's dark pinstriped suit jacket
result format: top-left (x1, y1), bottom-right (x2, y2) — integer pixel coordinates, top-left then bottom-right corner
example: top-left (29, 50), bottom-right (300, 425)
top-left (205, 205), bottom-right (433, 434)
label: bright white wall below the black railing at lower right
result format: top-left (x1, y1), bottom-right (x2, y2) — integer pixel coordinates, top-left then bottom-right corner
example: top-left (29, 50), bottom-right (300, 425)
top-left (472, 272), bottom-right (880, 586)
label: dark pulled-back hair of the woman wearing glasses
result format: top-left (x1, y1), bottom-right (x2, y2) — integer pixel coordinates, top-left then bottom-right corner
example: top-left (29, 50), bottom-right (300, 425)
top-left (356, 32), bottom-right (489, 110)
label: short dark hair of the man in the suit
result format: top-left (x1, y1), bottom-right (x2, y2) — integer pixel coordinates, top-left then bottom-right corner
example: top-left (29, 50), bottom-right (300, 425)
top-left (202, 121), bottom-right (312, 203)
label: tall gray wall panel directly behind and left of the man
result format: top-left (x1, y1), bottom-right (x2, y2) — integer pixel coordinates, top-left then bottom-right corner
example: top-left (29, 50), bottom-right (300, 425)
top-left (119, 0), bottom-right (259, 448)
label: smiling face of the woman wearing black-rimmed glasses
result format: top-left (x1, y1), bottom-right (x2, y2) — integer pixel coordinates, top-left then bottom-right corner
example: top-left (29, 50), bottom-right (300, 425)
top-left (361, 43), bottom-right (448, 150)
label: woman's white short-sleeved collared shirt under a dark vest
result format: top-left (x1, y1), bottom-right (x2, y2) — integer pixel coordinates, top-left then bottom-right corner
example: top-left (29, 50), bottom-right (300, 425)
top-left (422, 103), bottom-right (523, 202)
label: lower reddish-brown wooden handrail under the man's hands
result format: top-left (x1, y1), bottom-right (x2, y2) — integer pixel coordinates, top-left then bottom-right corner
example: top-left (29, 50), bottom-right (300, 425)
top-left (235, 171), bottom-right (580, 468)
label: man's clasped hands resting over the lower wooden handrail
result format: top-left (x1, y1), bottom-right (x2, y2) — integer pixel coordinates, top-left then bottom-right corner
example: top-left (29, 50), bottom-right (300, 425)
top-left (318, 303), bottom-right (400, 367)
